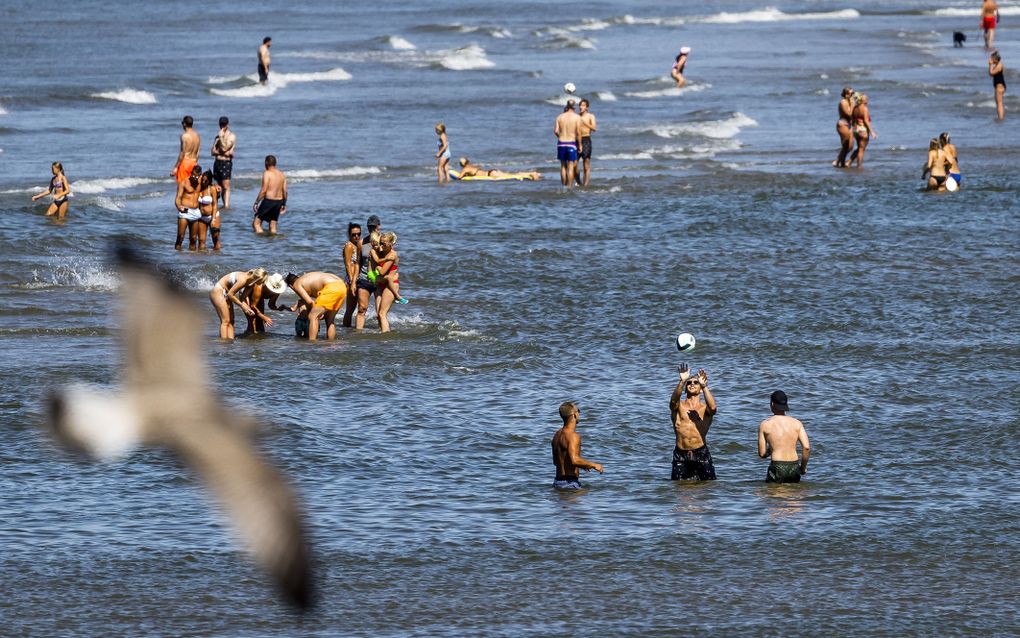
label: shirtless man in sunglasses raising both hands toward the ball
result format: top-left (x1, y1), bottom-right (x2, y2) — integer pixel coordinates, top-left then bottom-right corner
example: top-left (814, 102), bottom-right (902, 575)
top-left (669, 363), bottom-right (715, 481)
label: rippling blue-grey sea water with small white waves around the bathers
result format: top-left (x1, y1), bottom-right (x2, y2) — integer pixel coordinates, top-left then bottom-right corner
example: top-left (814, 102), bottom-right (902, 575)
top-left (0, 0), bottom-right (1020, 636)
